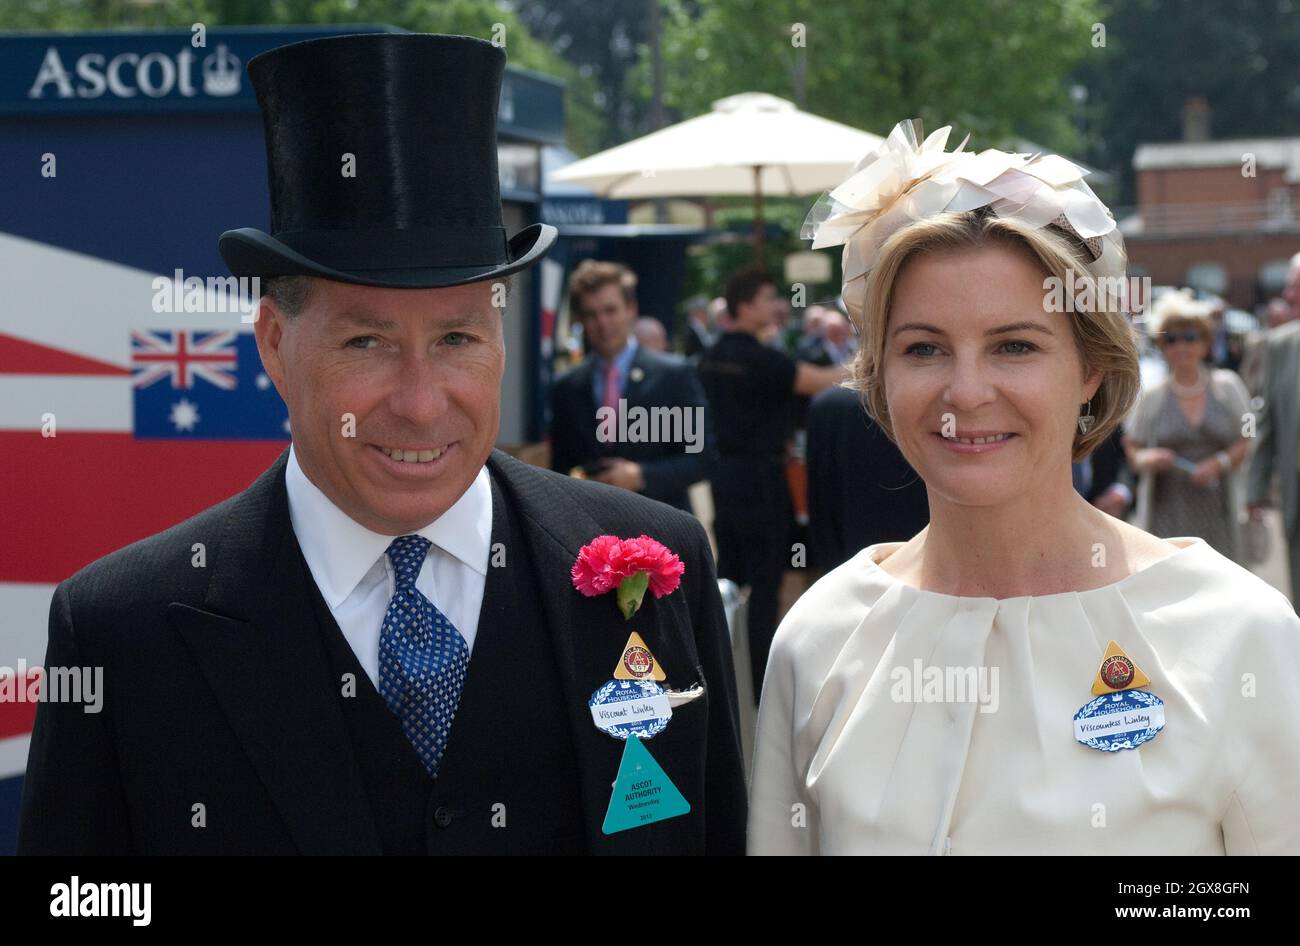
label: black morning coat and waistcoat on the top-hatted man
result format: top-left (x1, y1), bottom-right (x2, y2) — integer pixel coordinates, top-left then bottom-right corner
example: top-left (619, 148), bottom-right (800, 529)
top-left (18, 451), bottom-right (746, 854)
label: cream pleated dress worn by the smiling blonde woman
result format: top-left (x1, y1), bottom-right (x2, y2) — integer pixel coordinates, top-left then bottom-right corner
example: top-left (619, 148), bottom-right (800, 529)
top-left (749, 538), bottom-right (1300, 854)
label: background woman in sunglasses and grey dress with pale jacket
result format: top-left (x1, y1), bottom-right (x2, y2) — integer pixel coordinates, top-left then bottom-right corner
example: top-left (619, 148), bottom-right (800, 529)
top-left (1123, 290), bottom-right (1251, 561)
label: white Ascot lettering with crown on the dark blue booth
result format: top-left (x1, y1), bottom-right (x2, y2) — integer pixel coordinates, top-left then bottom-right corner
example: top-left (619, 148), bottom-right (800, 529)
top-left (27, 43), bottom-right (241, 99)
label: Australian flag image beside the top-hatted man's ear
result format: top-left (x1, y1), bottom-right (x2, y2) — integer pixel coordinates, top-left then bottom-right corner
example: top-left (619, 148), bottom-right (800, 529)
top-left (131, 330), bottom-right (289, 441)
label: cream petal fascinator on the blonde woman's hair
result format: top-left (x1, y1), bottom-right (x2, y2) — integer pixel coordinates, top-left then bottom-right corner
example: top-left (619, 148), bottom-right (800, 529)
top-left (800, 118), bottom-right (1127, 326)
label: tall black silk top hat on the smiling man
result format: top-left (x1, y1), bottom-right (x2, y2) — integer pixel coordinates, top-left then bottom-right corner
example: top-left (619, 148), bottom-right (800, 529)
top-left (218, 32), bottom-right (556, 288)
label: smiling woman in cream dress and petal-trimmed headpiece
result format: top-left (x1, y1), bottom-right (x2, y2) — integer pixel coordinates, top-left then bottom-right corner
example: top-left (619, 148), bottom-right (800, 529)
top-left (749, 125), bottom-right (1300, 855)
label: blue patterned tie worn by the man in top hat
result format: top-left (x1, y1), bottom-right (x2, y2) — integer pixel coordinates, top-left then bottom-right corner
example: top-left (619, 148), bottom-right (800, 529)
top-left (380, 535), bottom-right (469, 778)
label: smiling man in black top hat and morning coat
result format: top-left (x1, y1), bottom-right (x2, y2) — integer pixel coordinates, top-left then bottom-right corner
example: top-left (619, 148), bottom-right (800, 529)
top-left (18, 34), bottom-right (745, 854)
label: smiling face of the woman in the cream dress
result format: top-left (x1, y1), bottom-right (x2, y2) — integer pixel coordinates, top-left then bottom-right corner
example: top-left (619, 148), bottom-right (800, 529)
top-left (883, 246), bottom-right (1101, 505)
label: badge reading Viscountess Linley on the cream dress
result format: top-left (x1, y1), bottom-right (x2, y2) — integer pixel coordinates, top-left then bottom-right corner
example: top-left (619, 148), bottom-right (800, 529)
top-left (1074, 641), bottom-right (1165, 752)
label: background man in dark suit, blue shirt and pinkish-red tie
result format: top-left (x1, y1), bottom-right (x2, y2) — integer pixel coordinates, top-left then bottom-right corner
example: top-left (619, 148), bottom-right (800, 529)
top-left (551, 260), bottom-right (711, 512)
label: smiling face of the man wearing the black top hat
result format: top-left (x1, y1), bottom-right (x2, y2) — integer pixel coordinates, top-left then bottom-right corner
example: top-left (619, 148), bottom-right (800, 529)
top-left (256, 279), bottom-right (506, 535)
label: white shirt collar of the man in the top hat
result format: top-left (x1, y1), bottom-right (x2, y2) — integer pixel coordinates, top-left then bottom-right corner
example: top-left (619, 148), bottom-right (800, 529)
top-left (285, 446), bottom-right (491, 609)
